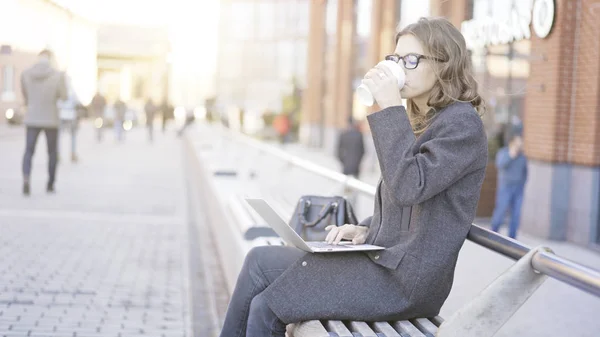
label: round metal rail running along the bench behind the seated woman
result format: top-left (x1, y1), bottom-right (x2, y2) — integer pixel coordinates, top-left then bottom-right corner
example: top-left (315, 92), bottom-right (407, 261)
top-left (227, 126), bottom-right (600, 297)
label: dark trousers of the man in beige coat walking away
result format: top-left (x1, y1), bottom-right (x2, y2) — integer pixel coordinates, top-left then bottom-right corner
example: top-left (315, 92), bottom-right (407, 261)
top-left (23, 126), bottom-right (58, 184)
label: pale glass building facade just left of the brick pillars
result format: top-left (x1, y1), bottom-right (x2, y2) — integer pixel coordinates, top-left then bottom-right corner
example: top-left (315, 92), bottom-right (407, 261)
top-left (215, 0), bottom-right (314, 131)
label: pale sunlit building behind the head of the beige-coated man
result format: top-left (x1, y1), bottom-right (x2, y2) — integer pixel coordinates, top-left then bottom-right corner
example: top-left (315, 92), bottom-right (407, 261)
top-left (0, 0), bottom-right (97, 118)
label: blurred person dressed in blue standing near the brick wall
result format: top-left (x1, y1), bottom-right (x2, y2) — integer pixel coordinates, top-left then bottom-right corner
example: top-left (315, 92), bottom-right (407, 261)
top-left (492, 128), bottom-right (527, 239)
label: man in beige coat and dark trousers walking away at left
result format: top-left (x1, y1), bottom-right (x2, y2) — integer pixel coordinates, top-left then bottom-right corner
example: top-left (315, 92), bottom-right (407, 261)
top-left (21, 49), bottom-right (67, 195)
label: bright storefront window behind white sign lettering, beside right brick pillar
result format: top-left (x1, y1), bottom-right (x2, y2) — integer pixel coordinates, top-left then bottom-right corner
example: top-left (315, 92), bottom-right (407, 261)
top-left (462, 0), bottom-right (531, 155)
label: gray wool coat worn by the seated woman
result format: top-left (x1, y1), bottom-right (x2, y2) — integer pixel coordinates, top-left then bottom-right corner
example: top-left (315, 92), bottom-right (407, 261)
top-left (264, 103), bottom-right (487, 323)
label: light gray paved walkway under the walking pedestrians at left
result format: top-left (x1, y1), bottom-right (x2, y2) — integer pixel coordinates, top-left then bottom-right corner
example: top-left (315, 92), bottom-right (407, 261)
top-left (0, 124), bottom-right (220, 337)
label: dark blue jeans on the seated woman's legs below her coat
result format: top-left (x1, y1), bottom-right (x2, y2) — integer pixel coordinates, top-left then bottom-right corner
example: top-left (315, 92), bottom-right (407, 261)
top-left (221, 246), bottom-right (306, 337)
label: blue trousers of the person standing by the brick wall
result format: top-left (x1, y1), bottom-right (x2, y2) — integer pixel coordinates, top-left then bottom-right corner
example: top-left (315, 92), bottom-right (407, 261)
top-left (492, 184), bottom-right (525, 239)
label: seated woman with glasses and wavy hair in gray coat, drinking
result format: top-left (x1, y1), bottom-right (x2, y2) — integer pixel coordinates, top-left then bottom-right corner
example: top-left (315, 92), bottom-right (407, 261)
top-left (221, 18), bottom-right (488, 337)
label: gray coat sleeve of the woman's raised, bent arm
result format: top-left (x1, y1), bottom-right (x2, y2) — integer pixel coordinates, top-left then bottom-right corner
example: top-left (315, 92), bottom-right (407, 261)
top-left (368, 106), bottom-right (487, 207)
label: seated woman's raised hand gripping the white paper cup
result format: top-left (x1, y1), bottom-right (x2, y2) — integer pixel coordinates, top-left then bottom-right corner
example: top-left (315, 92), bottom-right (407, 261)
top-left (362, 64), bottom-right (402, 109)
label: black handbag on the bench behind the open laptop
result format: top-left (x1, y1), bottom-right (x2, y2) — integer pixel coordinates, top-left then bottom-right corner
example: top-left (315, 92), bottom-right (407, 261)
top-left (290, 195), bottom-right (358, 241)
